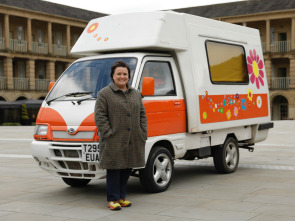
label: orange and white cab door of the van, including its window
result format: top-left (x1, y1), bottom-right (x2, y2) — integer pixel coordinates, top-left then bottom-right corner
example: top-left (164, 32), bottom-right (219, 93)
top-left (138, 57), bottom-right (186, 137)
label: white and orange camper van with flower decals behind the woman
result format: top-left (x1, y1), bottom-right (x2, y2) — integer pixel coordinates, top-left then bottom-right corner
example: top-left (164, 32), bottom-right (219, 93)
top-left (31, 12), bottom-right (273, 192)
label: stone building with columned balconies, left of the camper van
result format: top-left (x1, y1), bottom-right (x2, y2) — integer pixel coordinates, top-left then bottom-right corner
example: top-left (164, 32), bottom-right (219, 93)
top-left (0, 0), bottom-right (105, 125)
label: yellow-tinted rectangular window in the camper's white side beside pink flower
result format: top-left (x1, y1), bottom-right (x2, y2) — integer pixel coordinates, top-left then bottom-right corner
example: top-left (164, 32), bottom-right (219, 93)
top-left (206, 41), bottom-right (249, 84)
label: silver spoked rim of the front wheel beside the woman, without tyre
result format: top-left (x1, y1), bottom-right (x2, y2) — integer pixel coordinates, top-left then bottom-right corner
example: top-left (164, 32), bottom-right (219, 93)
top-left (153, 153), bottom-right (172, 186)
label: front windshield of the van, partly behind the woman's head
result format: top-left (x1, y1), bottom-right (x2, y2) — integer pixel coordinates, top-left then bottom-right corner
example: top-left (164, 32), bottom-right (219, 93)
top-left (46, 57), bottom-right (137, 102)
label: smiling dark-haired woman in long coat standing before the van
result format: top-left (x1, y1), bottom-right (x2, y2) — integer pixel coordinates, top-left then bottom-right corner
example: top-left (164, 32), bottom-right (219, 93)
top-left (95, 61), bottom-right (147, 210)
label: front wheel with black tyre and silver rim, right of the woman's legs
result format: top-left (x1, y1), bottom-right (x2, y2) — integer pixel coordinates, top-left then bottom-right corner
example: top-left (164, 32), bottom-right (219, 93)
top-left (139, 147), bottom-right (174, 193)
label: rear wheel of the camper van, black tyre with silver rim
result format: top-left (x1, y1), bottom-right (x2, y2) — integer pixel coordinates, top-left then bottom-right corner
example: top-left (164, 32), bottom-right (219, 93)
top-left (213, 137), bottom-right (239, 173)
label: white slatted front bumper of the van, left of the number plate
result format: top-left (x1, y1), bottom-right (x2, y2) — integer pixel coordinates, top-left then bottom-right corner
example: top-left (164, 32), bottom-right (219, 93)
top-left (31, 140), bottom-right (106, 179)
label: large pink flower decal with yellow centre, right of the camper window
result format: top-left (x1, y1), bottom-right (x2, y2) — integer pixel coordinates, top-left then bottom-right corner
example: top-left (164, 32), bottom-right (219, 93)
top-left (247, 49), bottom-right (264, 89)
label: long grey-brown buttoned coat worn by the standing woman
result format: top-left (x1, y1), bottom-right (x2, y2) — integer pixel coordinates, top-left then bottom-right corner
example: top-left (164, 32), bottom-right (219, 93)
top-left (95, 83), bottom-right (147, 169)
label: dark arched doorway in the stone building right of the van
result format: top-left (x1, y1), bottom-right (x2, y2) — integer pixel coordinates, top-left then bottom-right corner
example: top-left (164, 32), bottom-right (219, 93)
top-left (272, 95), bottom-right (289, 120)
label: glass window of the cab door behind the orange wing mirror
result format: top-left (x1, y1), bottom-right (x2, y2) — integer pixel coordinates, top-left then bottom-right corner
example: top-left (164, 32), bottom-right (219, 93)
top-left (139, 61), bottom-right (176, 96)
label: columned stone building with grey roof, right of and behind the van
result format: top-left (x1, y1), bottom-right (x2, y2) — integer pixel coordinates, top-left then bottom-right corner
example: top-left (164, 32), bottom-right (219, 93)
top-left (174, 0), bottom-right (295, 120)
